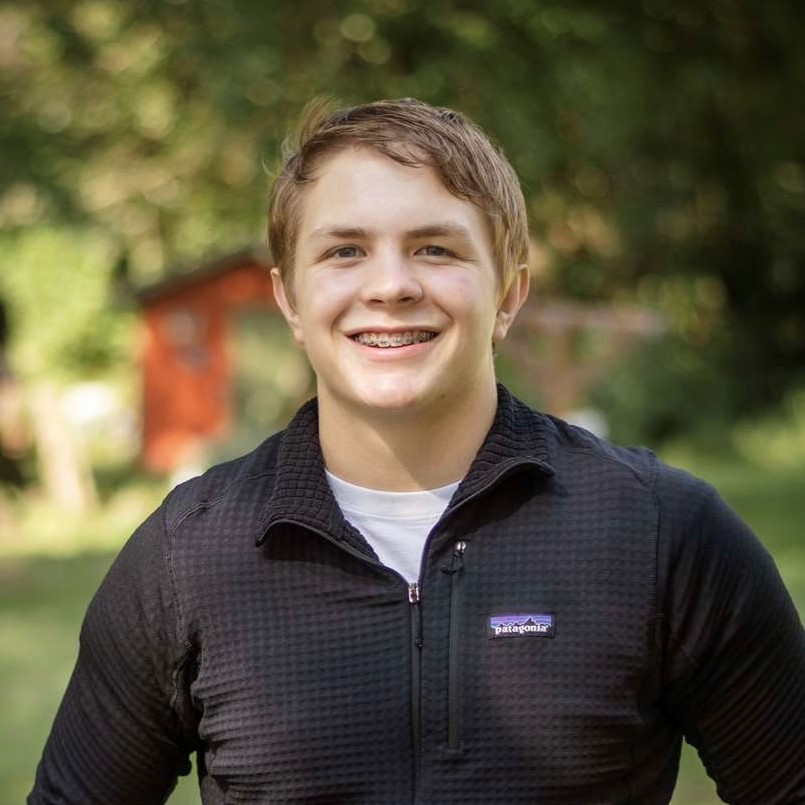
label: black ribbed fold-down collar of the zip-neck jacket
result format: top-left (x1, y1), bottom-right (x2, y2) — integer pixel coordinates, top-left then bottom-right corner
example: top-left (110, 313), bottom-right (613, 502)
top-left (256, 385), bottom-right (554, 545)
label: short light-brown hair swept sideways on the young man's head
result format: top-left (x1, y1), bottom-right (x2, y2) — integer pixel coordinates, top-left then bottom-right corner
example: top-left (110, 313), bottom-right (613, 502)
top-left (268, 98), bottom-right (528, 293)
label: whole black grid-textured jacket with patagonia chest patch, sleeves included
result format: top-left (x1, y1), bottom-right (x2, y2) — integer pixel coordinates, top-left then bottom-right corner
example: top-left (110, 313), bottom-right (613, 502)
top-left (28, 388), bottom-right (805, 805)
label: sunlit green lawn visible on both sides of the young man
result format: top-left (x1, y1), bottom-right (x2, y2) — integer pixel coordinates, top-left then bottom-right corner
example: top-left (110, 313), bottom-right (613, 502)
top-left (0, 454), bottom-right (805, 805)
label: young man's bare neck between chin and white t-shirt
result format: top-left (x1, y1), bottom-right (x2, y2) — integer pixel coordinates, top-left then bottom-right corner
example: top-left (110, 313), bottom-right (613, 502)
top-left (319, 384), bottom-right (497, 492)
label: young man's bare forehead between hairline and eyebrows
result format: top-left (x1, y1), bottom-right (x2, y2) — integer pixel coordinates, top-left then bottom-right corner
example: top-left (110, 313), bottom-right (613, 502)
top-left (299, 147), bottom-right (490, 239)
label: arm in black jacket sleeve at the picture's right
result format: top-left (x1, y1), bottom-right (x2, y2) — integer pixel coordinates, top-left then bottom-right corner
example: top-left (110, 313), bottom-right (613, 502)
top-left (660, 474), bottom-right (805, 805)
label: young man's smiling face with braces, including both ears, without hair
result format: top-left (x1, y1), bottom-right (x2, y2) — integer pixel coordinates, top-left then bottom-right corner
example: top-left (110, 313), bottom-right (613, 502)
top-left (272, 148), bottom-right (527, 424)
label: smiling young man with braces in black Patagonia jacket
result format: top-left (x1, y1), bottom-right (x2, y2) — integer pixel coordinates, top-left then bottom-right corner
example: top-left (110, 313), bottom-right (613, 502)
top-left (29, 101), bottom-right (805, 805)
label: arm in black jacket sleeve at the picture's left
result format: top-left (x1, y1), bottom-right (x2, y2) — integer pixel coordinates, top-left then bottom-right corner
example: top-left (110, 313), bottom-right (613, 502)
top-left (28, 511), bottom-right (193, 805)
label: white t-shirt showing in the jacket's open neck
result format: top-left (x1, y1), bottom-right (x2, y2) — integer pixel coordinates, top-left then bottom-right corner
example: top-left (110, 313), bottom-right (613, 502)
top-left (327, 472), bottom-right (458, 583)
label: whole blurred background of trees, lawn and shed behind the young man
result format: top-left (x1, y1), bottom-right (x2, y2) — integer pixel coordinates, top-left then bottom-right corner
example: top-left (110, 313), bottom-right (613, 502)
top-left (0, 0), bottom-right (805, 805)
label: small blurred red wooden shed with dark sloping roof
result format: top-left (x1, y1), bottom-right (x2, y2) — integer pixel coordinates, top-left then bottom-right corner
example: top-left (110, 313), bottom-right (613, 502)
top-left (139, 249), bottom-right (309, 472)
